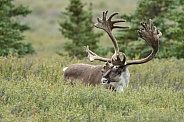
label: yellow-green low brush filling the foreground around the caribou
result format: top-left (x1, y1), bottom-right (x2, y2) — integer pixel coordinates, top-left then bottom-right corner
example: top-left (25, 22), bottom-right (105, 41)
top-left (0, 56), bottom-right (184, 122)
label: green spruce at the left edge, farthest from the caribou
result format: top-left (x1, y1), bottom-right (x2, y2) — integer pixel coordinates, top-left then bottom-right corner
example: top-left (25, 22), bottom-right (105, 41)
top-left (0, 0), bottom-right (34, 57)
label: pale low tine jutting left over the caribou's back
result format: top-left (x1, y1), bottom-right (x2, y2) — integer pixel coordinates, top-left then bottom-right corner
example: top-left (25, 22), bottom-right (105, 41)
top-left (84, 46), bottom-right (111, 62)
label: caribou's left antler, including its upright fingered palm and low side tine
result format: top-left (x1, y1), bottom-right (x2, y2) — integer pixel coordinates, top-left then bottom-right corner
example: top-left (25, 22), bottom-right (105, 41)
top-left (87, 11), bottom-right (129, 65)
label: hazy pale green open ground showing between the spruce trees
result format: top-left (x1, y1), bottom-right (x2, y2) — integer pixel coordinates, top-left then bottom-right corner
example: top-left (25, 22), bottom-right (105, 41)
top-left (14, 0), bottom-right (137, 57)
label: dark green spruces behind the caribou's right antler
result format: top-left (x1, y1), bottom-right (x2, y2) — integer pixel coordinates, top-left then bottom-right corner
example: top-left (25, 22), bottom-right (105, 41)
top-left (118, 0), bottom-right (184, 58)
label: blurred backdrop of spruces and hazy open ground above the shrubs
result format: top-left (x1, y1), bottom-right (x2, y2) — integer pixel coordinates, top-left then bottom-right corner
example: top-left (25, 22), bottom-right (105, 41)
top-left (0, 0), bottom-right (184, 59)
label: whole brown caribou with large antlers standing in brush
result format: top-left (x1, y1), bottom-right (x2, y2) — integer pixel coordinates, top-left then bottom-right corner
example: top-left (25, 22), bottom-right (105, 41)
top-left (63, 11), bottom-right (162, 92)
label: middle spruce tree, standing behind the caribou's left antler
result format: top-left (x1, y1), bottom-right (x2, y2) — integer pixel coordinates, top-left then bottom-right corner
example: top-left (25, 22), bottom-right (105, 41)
top-left (59, 0), bottom-right (105, 59)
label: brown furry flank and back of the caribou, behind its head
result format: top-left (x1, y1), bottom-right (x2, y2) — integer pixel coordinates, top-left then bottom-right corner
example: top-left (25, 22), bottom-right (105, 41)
top-left (64, 64), bottom-right (110, 88)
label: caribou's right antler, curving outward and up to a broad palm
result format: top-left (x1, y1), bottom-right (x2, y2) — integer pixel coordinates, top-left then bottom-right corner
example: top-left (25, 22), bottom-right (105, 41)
top-left (126, 19), bottom-right (162, 65)
